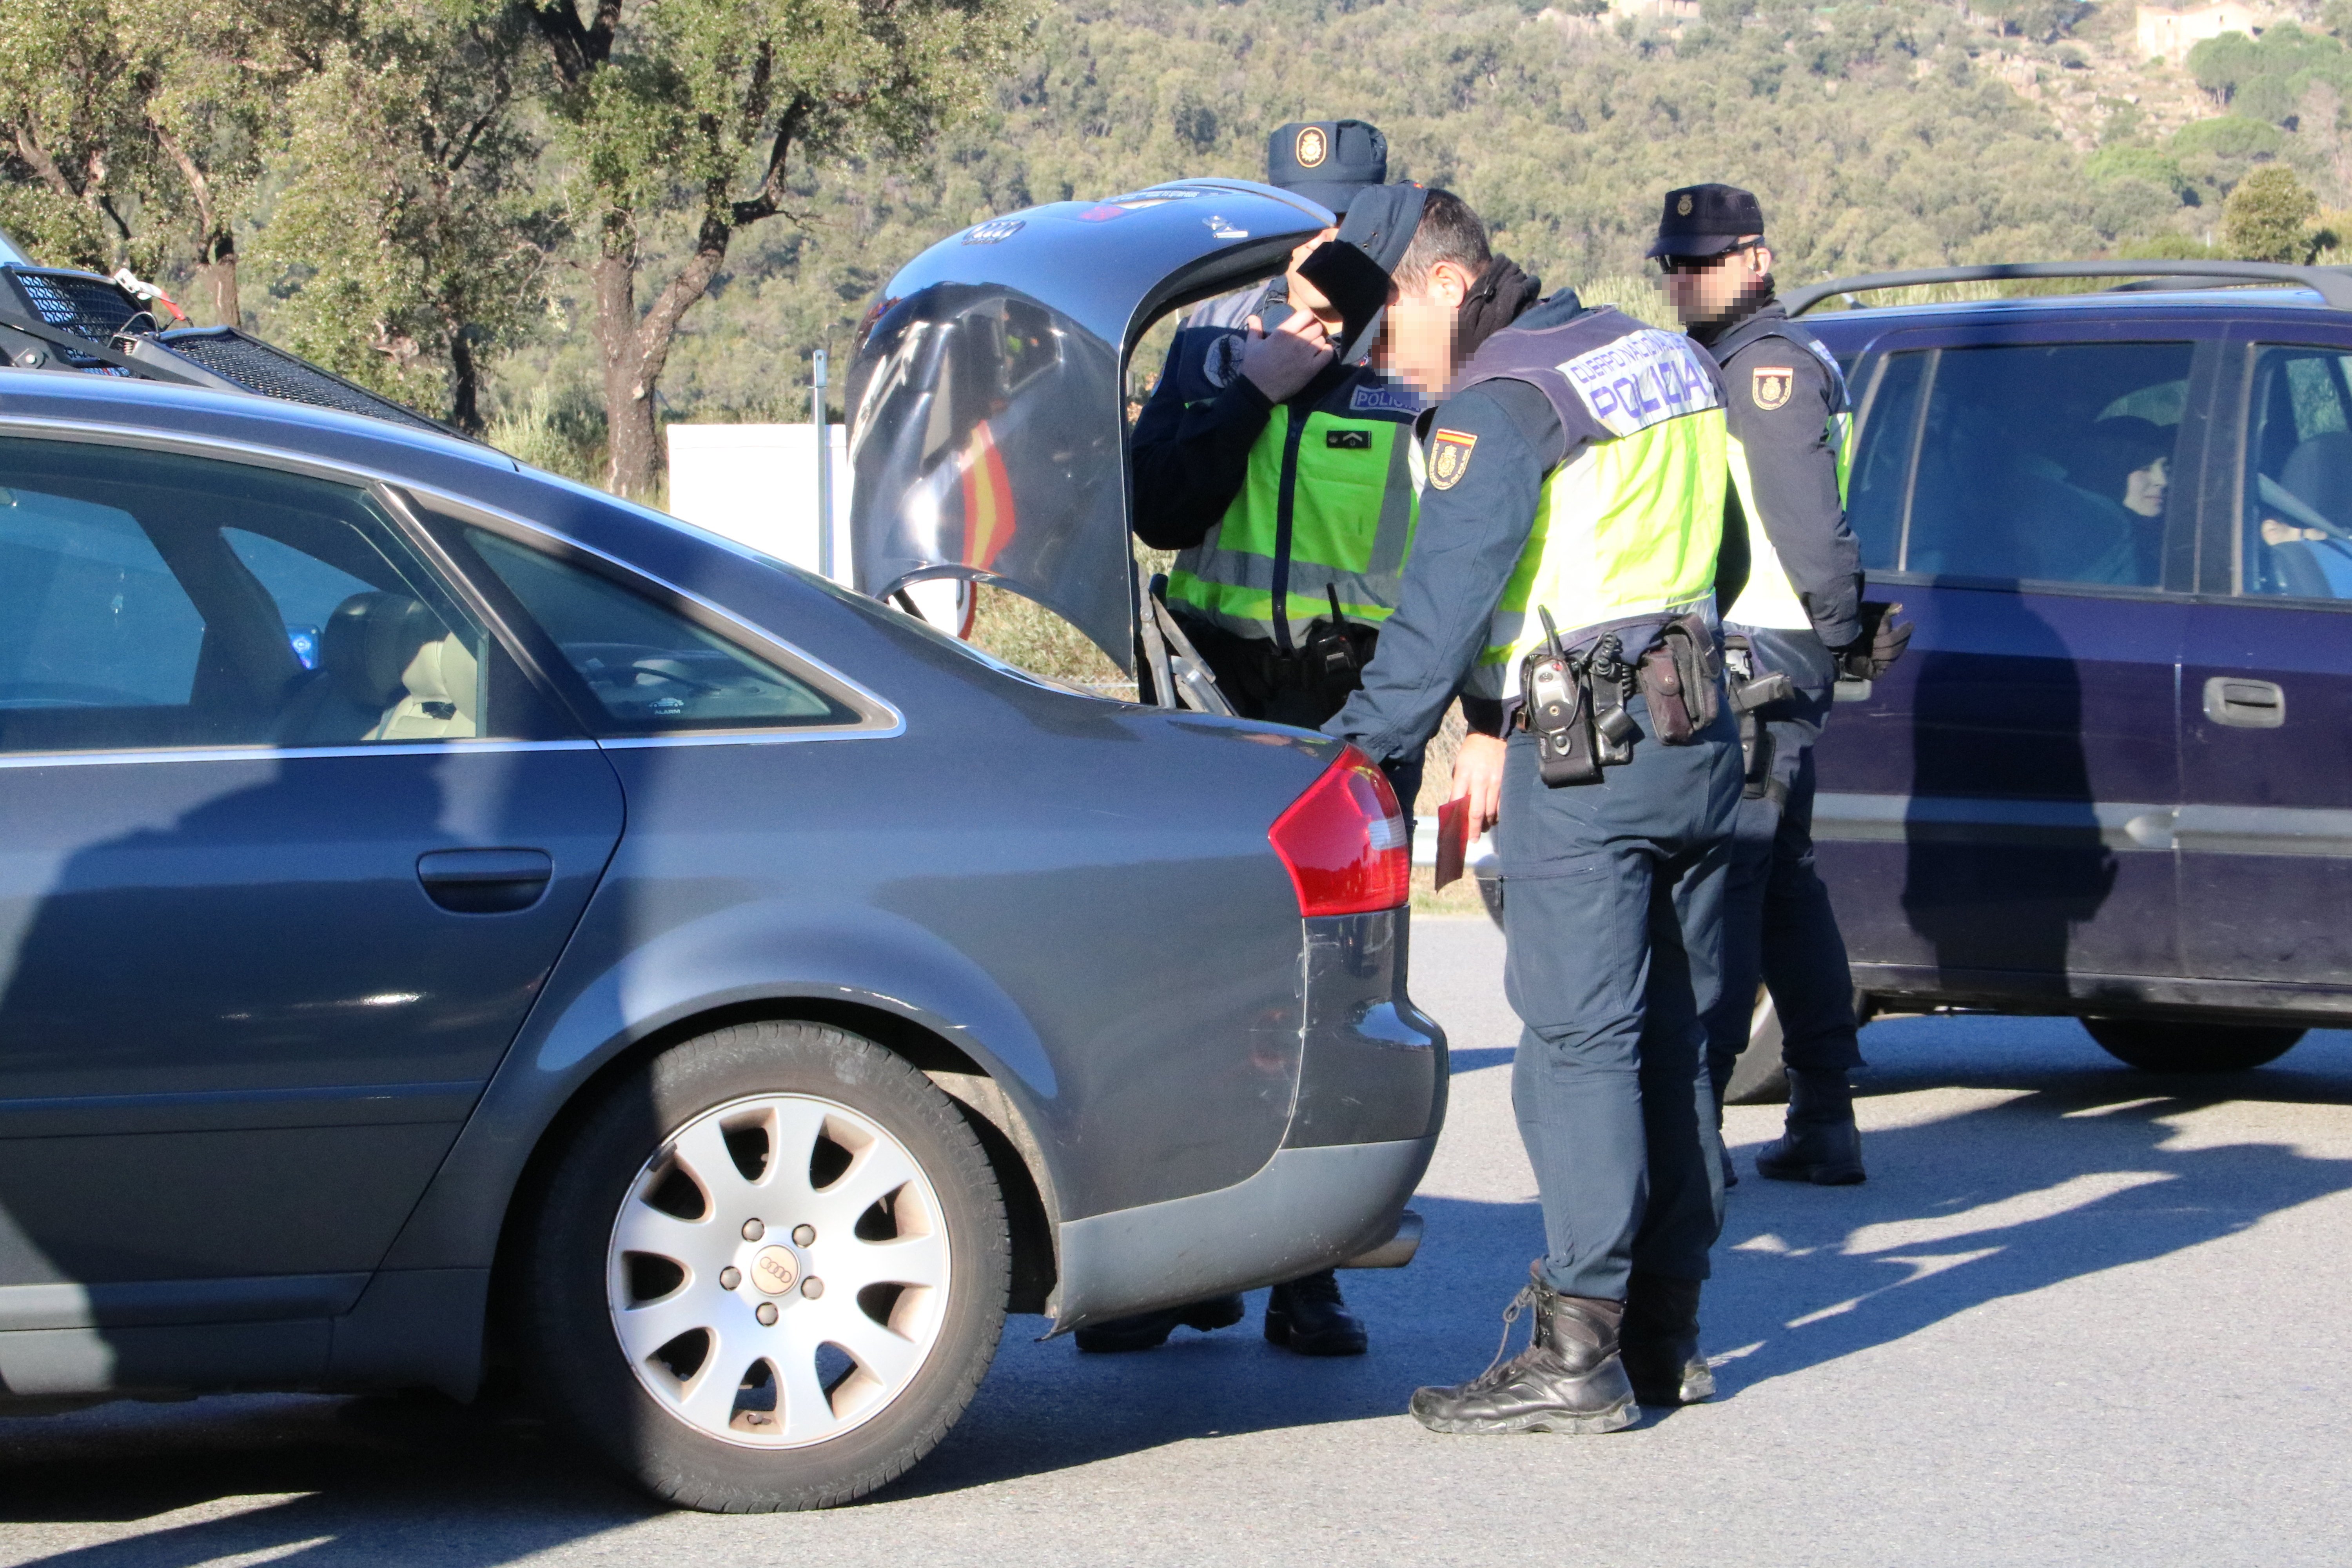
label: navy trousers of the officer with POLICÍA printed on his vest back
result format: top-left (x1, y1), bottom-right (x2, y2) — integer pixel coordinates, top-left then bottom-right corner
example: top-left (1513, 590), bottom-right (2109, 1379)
top-left (1496, 696), bottom-right (1740, 1300)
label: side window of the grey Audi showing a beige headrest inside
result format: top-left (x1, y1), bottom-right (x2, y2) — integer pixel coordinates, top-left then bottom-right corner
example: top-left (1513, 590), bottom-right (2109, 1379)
top-left (0, 439), bottom-right (510, 752)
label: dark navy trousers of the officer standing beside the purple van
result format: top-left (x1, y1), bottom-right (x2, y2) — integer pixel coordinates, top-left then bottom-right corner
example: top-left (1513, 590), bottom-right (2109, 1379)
top-left (1708, 628), bottom-right (1863, 1100)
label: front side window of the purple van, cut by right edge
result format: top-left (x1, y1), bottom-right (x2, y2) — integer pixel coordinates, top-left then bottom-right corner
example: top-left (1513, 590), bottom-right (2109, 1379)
top-left (2237, 346), bottom-right (2352, 599)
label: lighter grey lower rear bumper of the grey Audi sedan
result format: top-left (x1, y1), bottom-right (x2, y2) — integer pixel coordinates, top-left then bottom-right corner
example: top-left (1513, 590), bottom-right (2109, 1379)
top-left (1051, 1133), bottom-right (1437, 1333)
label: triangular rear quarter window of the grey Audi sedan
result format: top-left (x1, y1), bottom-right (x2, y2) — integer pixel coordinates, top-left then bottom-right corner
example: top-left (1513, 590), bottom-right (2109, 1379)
top-left (466, 529), bottom-right (858, 733)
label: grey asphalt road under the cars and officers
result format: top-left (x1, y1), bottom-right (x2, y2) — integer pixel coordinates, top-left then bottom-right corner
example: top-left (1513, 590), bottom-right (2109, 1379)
top-left (0, 919), bottom-right (2352, 1568)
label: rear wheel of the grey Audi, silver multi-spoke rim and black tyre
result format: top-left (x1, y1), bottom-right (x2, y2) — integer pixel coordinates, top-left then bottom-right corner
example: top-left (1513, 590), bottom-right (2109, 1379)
top-left (517, 1023), bottom-right (1009, 1514)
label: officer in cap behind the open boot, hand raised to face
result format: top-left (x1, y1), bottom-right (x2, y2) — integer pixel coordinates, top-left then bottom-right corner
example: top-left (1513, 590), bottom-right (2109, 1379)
top-left (1077, 138), bottom-right (1421, 1356)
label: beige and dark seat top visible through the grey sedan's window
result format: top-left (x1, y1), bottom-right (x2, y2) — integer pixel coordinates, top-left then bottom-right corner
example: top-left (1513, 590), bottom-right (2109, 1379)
top-left (278, 592), bottom-right (480, 745)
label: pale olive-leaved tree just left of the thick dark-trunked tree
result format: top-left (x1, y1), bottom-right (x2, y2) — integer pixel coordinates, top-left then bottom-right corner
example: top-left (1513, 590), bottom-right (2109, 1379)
top-left (259, 0), bottom-right (557, 432)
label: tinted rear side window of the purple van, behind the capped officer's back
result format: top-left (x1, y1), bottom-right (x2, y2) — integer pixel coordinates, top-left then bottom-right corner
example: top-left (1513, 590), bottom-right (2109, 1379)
top-left (1867, 343), bottom-right (2194, 588)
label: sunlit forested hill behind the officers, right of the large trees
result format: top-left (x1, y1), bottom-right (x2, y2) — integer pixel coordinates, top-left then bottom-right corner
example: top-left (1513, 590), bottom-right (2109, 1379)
top-left (621, 0), bottom-right (2352, 430)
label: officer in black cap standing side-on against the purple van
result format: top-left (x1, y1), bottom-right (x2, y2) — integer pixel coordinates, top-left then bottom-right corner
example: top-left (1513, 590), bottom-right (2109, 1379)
top-left (1649, 186), bottom-right (1910, 1185)
